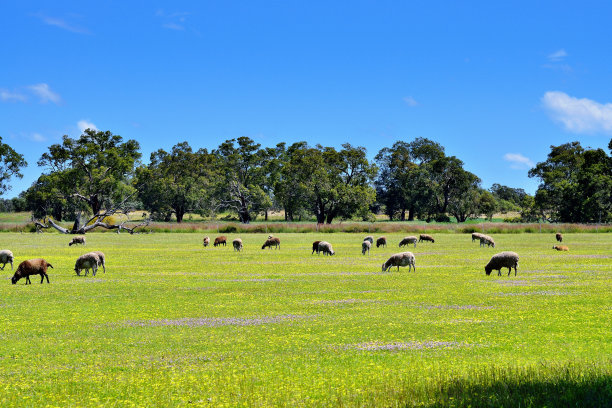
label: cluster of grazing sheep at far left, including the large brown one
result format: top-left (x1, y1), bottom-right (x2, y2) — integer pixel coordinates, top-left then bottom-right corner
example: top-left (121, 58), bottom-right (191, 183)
top-left (0, 236), bottom-right (106, 285)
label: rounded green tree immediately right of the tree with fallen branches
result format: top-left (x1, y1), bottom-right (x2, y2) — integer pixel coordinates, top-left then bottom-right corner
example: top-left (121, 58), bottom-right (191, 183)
top-left (135, 142), bottom-right (217, 223)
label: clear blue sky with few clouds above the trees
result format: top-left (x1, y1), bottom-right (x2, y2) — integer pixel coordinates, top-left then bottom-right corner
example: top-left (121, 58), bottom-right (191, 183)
top-left (0, 1), bottom-right (612, 197)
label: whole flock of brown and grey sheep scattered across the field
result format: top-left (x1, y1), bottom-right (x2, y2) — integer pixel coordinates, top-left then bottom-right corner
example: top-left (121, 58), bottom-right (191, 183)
top-left (0, 232), bottom-right (569, 285)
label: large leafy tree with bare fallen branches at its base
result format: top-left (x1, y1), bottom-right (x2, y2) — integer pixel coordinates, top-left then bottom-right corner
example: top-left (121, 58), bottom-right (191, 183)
top-left (33, 129), bottom-right (145, 234)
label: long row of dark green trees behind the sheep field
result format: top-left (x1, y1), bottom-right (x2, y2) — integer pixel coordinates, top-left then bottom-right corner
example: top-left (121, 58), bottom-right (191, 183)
top-left (3, 129), bottom-right (612, 225)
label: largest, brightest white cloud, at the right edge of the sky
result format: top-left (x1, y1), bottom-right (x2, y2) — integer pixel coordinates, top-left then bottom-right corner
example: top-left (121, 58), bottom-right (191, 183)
top-left (542, 91), bottom-right (612, 133)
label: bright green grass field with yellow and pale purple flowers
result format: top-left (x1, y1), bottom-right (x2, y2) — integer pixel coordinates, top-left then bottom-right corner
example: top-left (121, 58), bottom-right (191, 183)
top-left (0, 233), bottom-right (612, 407)
